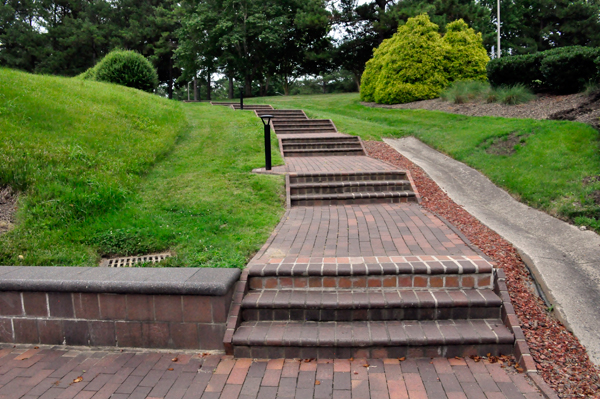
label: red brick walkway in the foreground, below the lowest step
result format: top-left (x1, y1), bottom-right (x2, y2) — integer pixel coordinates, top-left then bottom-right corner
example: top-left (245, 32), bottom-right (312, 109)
top-left (0, 346), bottom-right (542, 399)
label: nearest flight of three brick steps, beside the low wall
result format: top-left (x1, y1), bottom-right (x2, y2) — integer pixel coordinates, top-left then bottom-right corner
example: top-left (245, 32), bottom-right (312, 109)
top-left (232, 257), bottom-right (514, 358)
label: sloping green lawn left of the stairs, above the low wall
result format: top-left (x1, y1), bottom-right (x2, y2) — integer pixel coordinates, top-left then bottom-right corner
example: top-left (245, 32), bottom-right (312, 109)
top-left (0, 69), bottom-right (284, 267)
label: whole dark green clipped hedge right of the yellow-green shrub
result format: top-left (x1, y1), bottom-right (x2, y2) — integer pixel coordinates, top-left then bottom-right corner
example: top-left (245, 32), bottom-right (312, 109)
top-left (487, 46), bottom-right (600, 93)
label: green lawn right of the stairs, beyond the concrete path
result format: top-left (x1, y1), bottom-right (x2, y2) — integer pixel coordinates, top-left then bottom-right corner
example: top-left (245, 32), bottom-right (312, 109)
top-left (247, 94), bottom-right (600, 232)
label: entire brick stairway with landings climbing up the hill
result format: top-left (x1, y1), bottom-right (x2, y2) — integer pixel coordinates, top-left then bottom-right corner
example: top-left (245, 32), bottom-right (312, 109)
top-left (214, 102), bottom-right (515, 358)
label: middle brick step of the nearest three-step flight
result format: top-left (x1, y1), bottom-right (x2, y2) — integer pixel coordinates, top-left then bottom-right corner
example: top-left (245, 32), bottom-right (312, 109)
top-left (241, 289), bottom-right (502, 321)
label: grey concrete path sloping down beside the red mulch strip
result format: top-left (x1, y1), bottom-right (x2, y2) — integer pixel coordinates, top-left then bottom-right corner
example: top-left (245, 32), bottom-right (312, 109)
top-left (384, 137), bottom-right (600, 364)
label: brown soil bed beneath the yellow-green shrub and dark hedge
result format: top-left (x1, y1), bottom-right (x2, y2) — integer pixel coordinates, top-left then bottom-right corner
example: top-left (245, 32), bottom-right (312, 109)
top-left (361, 91), bottom-right (600, 129)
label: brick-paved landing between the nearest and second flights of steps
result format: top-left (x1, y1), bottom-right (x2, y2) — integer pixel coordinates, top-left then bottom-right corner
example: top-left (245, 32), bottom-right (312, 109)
top-left (254, 203), bottom-right (477, 262)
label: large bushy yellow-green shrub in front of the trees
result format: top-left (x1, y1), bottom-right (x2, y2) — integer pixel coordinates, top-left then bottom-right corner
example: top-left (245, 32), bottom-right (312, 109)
top-left (361, 14), bottom-right (489, 104)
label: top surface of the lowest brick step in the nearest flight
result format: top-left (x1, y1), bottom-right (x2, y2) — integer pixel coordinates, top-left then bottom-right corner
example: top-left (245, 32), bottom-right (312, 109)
top-left (232, 319), bottom-right (515, 347)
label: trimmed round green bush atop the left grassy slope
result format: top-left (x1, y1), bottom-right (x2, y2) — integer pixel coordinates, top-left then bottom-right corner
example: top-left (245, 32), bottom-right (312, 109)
top-left (93, 50), bottom-right (158, 92)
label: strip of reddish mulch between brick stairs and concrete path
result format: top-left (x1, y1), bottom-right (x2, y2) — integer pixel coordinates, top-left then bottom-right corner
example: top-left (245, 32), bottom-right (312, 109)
top-left (364, 141), bottom-right (600, 398)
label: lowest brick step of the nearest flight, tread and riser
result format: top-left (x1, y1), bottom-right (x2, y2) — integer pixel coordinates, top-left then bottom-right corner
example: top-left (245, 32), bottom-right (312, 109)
top-left (232, 319), bottom-right (515, 358)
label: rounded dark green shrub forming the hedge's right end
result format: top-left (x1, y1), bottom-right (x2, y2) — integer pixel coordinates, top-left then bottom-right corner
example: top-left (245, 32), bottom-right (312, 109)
top-left (540, 46), bottom-right (600, 93)
